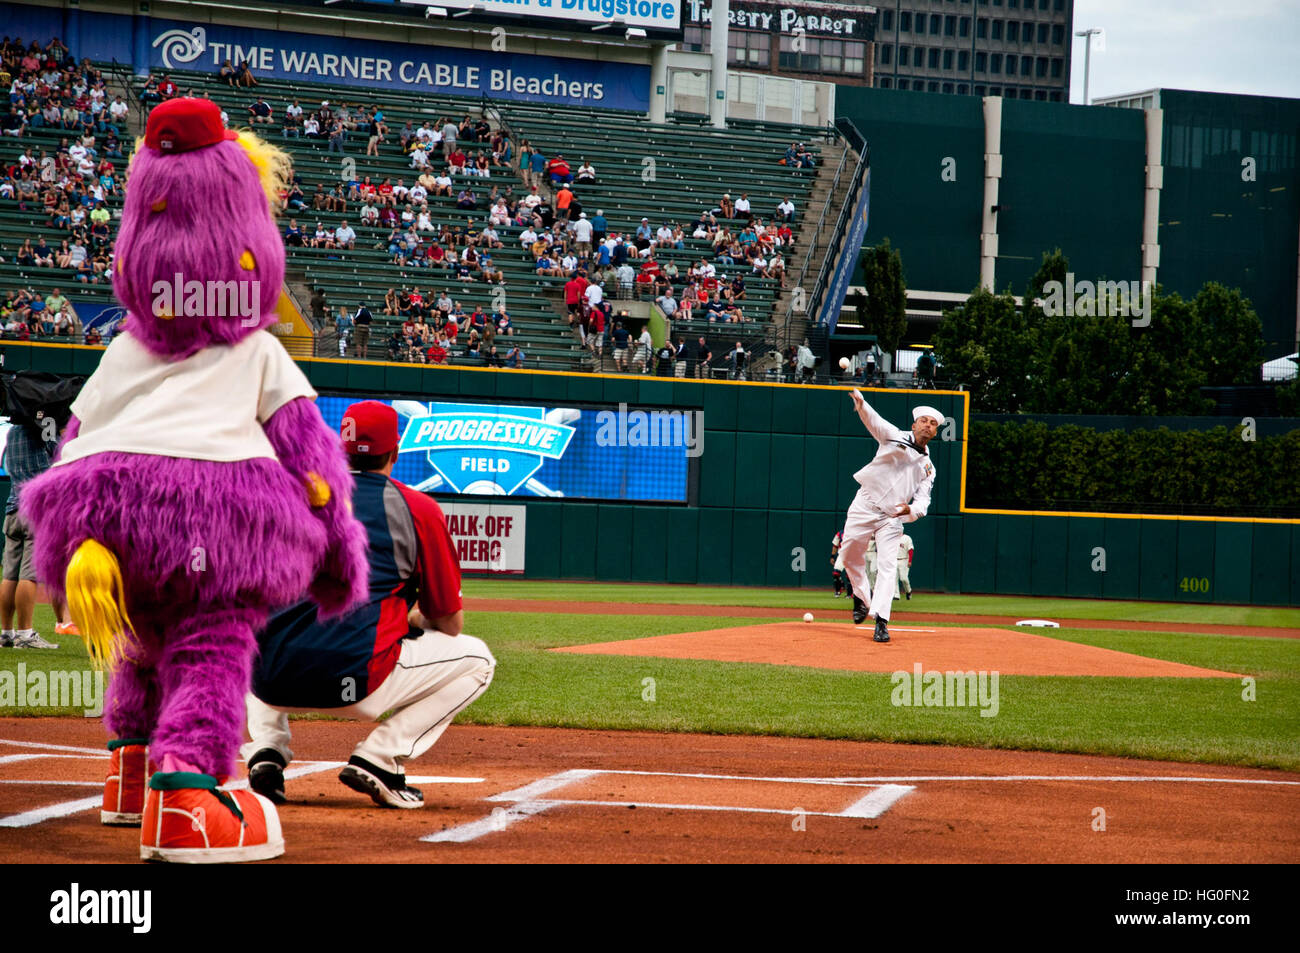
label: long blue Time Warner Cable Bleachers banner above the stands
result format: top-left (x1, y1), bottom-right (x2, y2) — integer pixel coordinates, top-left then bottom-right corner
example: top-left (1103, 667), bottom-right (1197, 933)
top-left (0, 4), bottom-right (650, 112)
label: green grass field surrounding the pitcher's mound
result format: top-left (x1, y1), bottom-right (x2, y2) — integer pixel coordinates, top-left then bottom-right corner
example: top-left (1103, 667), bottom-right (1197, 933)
top-left (0, 580), bottom-right (1300, 771)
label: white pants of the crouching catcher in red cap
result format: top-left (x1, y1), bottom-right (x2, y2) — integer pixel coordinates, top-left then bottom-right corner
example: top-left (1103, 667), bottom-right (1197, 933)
top-left (239, 631), bottom-right (497, 774)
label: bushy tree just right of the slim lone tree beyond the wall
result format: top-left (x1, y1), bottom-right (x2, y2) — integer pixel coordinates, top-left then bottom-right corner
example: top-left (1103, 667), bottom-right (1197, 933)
top-left (933, 287), bottom-right (1034, 413)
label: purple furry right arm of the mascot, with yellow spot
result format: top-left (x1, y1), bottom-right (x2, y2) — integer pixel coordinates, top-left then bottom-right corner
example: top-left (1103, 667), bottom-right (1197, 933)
top-left (263, 397), bottom-right (369, 619)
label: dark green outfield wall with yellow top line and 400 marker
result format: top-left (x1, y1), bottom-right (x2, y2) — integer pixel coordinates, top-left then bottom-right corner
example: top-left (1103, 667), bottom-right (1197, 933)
top-left (0, 345), bottom-right (1300, 606)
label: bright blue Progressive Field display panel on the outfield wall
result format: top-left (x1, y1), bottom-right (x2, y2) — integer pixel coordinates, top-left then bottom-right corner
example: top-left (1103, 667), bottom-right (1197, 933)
top-left (317, 397), bottom-right (702, 503)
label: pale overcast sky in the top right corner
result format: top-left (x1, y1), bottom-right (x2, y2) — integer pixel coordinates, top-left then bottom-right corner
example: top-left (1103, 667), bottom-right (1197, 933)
top-left (1070, 0), bottom-right (1300, 103)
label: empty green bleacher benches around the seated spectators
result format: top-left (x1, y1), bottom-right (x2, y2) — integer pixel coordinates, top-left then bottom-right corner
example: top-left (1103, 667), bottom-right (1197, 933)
top-left (0, 43), bottom-right (824, 371)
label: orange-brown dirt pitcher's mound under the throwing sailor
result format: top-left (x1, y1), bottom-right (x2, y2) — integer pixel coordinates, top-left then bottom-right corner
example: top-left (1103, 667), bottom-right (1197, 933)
top-left (551, 623), bottom-right (1242, 679)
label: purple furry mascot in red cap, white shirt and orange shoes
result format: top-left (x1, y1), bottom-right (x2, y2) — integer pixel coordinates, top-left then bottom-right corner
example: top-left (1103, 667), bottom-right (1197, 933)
top-left (22, 99), bottom-right (367, 862)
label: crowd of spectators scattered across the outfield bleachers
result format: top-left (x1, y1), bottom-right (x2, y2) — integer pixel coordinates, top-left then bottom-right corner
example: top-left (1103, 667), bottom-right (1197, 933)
top-left (0, 44), bottom-right (813, 374)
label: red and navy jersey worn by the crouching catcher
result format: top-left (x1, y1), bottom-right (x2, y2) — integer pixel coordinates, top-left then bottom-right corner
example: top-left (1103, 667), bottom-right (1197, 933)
top-left (252, 473), bottom-right (460, 709)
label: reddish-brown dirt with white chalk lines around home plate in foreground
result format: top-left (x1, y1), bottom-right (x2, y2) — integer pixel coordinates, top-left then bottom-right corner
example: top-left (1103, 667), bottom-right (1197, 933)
top-left (0, 719), bottom-right (1300, 863)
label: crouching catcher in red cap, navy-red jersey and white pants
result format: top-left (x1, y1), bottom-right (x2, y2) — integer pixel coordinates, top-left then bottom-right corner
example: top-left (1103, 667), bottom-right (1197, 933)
top-left (242, 400), bottom-right (497, 807)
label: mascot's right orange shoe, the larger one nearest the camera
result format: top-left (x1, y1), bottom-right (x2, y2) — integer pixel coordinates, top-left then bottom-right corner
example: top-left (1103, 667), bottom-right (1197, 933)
top-left (140, 771), bottom-right (285, 863)
